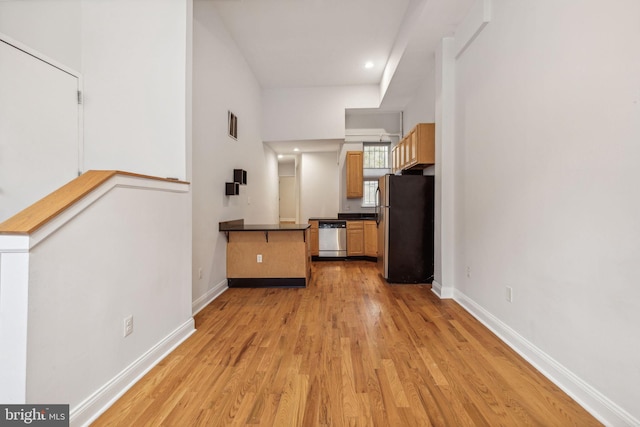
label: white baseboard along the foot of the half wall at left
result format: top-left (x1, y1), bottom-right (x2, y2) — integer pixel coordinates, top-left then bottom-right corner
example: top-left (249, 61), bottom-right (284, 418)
top-left (69, 318), bottom-right (196, 426)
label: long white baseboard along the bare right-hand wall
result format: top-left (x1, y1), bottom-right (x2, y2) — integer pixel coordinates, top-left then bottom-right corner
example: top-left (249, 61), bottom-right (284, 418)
top-left (454, 289), bottom-right (640, 426)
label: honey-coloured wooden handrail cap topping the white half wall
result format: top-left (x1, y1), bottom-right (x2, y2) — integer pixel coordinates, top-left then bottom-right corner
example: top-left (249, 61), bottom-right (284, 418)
top-left (0, 170), bottom-right (188, 234)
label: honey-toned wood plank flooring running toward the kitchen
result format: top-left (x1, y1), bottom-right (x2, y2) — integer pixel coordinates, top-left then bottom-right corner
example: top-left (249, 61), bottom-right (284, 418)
top-left (93, 261), bottom-right (601, 426)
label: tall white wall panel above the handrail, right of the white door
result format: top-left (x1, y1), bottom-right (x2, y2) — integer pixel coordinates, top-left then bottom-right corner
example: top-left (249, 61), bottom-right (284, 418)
top-left (82, 0), bottom-right (187, 179)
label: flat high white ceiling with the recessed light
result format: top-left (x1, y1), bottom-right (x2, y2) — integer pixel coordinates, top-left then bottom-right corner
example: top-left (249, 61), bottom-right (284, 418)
top-left (214, 0), bottom-right (409, 88)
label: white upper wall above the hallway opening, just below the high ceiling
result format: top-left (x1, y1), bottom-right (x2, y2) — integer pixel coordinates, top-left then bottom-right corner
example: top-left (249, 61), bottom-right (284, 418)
top-left (262, 85), bottom-right (380, 141)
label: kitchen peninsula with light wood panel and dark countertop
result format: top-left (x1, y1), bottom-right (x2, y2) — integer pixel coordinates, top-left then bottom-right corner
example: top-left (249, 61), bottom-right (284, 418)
top-left (219, 219), bottom-right (311, 288)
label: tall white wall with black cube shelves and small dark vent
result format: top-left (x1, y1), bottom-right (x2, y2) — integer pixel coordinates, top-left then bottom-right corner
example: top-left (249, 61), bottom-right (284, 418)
top-left (192, 1), bottom-right (278, 310)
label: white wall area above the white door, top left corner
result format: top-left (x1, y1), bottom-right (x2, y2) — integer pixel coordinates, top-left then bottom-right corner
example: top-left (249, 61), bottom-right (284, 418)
top-left (0, 0), bottom-right (82, 71)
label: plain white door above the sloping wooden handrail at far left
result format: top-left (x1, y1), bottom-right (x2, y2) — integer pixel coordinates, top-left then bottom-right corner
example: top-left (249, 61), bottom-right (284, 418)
top-left (0, 40), bottom-right (80, 222)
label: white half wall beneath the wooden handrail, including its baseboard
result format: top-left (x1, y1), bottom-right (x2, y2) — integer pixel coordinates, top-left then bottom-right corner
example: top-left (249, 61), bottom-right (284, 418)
top-left (0, 176), bottom-right (194, 424)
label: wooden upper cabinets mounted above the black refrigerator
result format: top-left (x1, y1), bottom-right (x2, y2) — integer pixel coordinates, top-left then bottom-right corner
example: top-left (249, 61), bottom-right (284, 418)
top-left (391, 123), bottom-right (436, 173)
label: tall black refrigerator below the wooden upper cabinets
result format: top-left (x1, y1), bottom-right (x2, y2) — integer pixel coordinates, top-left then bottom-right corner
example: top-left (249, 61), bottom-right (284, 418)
top-left (376, 175), bottom-right (435, 283)
